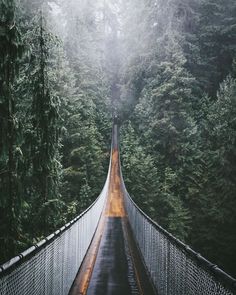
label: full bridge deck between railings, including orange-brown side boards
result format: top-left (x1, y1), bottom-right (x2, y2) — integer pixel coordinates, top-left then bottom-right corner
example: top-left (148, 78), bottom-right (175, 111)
top-left (70, 147), bottom-right (154, 295)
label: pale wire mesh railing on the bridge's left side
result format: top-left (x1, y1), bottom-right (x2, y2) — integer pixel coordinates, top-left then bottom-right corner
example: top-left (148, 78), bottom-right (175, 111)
top-left (0, 173), bottom-right (109, 295)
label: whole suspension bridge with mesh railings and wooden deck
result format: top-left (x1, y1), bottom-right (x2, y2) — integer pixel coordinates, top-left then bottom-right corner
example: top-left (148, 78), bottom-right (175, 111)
top-left (0, 124), bottom-right (236, 295)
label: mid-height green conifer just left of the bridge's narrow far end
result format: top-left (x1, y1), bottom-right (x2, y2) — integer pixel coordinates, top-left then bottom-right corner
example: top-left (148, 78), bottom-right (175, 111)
top-left (60, 96), bottom-right (108, 212)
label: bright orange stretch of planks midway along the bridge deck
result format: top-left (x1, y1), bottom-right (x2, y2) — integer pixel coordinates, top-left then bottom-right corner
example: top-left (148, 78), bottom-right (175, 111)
top-left (106, 149), bottom-right (125, 217)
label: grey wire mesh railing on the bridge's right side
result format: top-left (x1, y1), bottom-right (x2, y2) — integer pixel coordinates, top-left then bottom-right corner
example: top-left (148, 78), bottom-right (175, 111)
top-left (122, 192), bottom-right (236, 295)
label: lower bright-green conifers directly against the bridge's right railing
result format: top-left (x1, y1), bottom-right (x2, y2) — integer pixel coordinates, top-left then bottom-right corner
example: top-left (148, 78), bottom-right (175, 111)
top-left (121, 122), bottom-right (190, 240)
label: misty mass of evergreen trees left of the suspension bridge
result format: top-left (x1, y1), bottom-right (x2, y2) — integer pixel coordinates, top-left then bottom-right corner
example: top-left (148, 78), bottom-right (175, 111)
top-left (0, 0), bottom-right (110, 263)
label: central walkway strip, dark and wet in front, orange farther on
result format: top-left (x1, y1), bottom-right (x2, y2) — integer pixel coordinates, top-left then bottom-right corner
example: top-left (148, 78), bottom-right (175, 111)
top-left (87, 150), bottom-right (140, 295)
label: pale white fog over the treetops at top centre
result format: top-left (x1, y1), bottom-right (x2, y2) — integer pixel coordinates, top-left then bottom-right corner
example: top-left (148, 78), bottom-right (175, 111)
top-left (18, 0), bottom-right (200, 111)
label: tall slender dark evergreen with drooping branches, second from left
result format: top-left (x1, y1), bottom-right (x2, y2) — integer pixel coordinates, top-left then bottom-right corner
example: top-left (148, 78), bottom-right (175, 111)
top-left (28, 12), bottom-right (60, 234)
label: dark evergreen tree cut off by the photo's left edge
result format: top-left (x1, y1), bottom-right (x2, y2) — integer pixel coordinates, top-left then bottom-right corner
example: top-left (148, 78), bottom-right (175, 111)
top-left (0, 0), bottom-right (23, 260)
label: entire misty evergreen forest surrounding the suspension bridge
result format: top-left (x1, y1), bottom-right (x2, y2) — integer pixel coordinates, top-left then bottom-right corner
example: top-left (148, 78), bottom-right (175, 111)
top-left (0, 0), bottom-right (236, 276)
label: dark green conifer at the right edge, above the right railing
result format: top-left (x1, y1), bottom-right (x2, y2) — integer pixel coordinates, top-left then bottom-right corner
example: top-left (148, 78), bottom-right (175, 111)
top-left (189, 76), bottom-right (236, 273)
